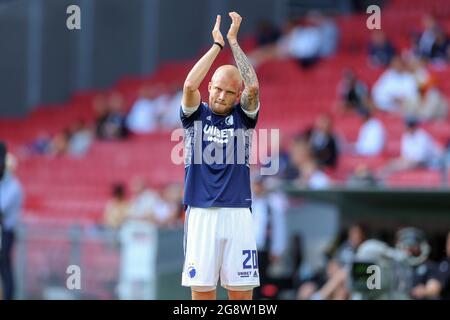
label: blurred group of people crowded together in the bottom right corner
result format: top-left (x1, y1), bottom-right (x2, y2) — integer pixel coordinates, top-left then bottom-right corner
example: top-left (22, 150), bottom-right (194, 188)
top-left (297, 224), bottom-right (450, 300)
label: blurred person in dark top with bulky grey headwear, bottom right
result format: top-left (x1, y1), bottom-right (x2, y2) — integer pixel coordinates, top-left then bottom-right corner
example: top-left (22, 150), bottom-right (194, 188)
top-left (396, 227), bottom-right (442, 299)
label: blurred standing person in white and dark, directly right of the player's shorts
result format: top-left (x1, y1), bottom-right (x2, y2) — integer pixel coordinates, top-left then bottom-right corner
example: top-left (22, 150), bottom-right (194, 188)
top-left (252, 175), bottom-right (287, 299)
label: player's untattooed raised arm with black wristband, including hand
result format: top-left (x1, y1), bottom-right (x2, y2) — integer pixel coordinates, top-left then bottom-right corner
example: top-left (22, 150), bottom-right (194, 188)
top-left (182, 15), bottom-right (225, 114)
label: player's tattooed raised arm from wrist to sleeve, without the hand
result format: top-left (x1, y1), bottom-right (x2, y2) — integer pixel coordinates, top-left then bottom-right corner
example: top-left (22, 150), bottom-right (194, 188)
top-left (231, 43), bottom-right (259, 110)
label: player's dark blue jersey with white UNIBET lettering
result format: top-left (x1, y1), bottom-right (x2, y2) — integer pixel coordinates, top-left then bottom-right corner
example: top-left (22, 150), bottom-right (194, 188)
top-left (181, 102), bottom-right (257, 208)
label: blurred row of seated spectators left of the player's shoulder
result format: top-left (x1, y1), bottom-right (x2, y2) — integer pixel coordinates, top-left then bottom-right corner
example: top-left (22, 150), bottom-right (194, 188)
top-left (23, 83), bottom-right (182, 157)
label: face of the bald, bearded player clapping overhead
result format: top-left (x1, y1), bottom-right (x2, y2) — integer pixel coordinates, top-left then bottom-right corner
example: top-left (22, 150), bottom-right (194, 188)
top-left (208, 74), bottom-right (241, 115)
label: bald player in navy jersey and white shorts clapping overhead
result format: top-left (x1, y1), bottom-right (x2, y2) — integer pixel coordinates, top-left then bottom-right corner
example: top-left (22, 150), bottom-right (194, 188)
top-left (181, 12), bottom-right (259, 300)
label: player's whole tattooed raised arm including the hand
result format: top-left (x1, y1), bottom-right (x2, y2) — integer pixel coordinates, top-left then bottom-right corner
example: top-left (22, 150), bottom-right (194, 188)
top-left (227, 12), bottom-right (259, 117)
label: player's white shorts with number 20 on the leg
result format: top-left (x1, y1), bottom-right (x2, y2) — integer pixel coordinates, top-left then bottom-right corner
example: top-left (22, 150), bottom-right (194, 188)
top-left (182, 208), bottom-right (259, 291)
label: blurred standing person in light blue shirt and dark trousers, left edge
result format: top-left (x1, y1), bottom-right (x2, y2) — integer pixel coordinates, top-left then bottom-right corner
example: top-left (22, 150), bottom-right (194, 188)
top-left (0, 154), bottom-right (24, 300)
